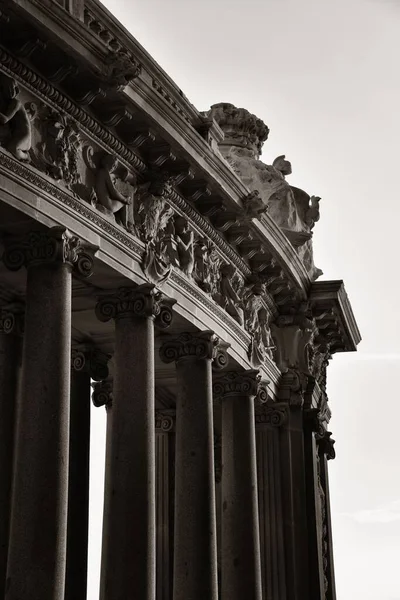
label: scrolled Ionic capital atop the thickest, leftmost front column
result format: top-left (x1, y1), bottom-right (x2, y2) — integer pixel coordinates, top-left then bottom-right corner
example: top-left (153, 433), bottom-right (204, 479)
top-left (3, 227), bottom-right (97, 278)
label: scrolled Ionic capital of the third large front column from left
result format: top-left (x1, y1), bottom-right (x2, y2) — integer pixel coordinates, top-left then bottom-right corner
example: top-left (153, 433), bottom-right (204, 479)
top-left (160, 331), bottom-right (229, 370)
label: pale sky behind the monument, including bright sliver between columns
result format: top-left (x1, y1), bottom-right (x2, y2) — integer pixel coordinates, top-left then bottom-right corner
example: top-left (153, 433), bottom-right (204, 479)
top-left (89, 0), bottom-right (400, 600)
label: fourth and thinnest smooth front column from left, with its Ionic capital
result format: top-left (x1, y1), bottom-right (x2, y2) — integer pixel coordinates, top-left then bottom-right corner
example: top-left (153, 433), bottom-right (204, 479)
top-left (213, 370), bottom-right (267, 600)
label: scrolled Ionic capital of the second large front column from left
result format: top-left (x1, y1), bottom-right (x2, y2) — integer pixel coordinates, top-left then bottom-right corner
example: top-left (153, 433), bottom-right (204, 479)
top-left (96, 283), bottom-right (176, 329)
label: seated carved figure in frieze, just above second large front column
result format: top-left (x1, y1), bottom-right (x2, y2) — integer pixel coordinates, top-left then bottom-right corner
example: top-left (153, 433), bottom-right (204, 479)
top-left (95, 154), bottom-right (133, 229)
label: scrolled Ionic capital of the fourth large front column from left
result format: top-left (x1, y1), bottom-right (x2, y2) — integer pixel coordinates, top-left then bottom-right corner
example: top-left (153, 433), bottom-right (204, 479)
top-left (213, 369), bottom-right (268, 402)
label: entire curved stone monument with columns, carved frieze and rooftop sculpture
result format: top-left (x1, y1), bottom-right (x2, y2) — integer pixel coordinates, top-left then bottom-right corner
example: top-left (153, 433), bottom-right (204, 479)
top-left (0, 0), bottom-right (360, 600)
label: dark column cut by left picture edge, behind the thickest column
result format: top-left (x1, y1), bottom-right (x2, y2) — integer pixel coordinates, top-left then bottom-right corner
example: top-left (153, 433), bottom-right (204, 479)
top-left (0, 306), bottom-right (23, 598)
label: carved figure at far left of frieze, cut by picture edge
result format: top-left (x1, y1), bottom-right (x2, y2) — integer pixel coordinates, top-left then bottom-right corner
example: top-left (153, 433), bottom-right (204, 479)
top-left (0, 75), bottom-right (36, 162)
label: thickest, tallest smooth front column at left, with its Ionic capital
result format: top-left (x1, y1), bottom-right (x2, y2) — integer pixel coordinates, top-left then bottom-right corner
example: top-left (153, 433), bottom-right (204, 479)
top-left (4, 228), bottom-right (93, 600)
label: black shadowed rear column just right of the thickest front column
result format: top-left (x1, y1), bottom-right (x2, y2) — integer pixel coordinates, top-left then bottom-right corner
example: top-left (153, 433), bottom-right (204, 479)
top-left (65, 347), bottom-right (109, 600)
